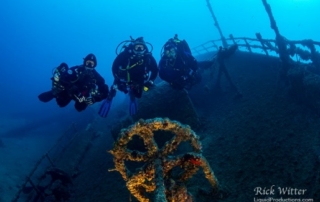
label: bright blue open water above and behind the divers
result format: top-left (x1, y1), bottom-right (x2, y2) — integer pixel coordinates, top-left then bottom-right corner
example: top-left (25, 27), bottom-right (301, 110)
top-left (0, 0), bottom-right (320, 200)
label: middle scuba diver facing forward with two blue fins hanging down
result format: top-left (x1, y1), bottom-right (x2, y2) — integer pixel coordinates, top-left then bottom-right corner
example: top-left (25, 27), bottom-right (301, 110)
top-left (99, 37), bottom-right (158, 117)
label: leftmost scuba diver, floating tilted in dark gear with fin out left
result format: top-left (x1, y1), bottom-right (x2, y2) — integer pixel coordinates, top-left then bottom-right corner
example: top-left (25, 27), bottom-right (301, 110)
top-left (38, 54), bottom-right (109, 112)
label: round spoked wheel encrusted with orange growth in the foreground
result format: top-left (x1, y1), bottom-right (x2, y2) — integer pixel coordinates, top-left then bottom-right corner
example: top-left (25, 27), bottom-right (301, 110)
top-left (110, 118), bottom-right (218, 202)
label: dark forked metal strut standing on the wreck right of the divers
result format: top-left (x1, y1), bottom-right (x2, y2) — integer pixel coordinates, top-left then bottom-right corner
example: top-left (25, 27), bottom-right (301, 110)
top-left (214, 44), bottom-right (242, 98)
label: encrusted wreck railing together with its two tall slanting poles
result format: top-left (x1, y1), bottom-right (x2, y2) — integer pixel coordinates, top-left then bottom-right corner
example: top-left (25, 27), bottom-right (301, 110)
top-left (198, 0), bottom-right (320, 72)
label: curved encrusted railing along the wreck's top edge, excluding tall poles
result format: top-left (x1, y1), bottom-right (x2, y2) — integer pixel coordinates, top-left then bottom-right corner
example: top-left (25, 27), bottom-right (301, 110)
top-left (192, 33), bottom-right (320, 64)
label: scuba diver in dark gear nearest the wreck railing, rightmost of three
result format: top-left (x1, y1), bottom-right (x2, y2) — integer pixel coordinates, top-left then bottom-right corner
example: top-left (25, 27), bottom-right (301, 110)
top-left (159, 34), bottom-right (201, 90)
